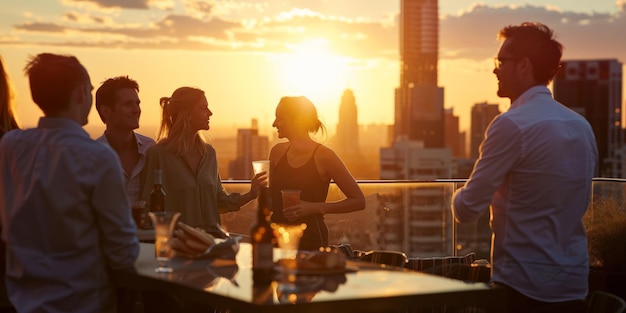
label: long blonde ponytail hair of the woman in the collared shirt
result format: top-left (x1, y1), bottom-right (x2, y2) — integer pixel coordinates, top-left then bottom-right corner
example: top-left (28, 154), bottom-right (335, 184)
top-left (157, 87), bottom-right (205, 156)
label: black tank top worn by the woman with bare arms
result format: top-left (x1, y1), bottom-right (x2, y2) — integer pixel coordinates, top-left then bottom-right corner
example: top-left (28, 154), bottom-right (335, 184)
top-left (270, 144), bottom-right (330, 250)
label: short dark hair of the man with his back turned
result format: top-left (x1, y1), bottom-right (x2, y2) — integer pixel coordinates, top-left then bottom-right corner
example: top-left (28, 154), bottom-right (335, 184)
top-left (24, 53), bottom-right (87, 115)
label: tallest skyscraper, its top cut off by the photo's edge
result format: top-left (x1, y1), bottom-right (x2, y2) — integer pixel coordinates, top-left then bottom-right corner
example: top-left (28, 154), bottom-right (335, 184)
top-left (394, 0), bottom-right (445, 148)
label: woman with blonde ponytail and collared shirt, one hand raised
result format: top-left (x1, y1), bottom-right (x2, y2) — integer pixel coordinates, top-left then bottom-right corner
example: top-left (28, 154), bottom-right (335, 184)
top-left (142, 87), bottom-right (265, 238)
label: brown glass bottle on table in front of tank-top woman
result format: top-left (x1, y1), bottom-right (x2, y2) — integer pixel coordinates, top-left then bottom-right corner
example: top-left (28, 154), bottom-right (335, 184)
top-left (251, 188), bottom-right (275, 284)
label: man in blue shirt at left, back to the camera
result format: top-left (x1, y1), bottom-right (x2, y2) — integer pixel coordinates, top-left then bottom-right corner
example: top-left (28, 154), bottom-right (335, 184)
top-left (0, 53), bottom-right (139, 313)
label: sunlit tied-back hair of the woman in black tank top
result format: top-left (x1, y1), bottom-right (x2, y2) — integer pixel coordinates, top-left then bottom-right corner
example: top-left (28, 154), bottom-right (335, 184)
top-left (278, 96), bottom-right (326, 134)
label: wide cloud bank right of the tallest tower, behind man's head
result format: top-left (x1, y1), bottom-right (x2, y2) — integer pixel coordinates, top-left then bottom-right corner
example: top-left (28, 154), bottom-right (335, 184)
top-left (439, 5), bottom-right (626, 61)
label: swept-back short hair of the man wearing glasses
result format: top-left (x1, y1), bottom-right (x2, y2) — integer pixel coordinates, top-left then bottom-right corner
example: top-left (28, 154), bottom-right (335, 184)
top-left (498, 22), bottom-right (563, 85)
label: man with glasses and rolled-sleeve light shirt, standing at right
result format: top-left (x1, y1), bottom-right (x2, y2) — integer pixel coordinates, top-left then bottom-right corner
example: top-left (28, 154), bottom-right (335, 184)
top-left (452, 23), bottom-right (598, 312)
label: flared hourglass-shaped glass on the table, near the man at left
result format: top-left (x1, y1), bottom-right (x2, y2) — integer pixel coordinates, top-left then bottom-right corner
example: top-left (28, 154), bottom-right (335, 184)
top-left (148, 211), bottom-right (180, 273)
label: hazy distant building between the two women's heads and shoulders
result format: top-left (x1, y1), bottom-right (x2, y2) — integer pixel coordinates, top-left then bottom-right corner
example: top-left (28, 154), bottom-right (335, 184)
top-left (228, 119), bottom-right (269, 179)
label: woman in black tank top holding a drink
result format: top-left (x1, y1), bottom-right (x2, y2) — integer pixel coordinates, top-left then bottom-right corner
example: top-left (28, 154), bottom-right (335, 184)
top-left (270, 97), bottom-right (365, 250)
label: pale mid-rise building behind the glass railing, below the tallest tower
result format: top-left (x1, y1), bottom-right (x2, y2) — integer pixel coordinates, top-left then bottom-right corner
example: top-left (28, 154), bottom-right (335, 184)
top-left (378, 139), bottom-right (452, 256)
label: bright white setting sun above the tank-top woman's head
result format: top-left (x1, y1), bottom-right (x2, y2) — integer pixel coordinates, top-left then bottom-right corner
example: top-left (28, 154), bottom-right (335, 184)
top-left (278, 39), bottom-right (349, 101)
